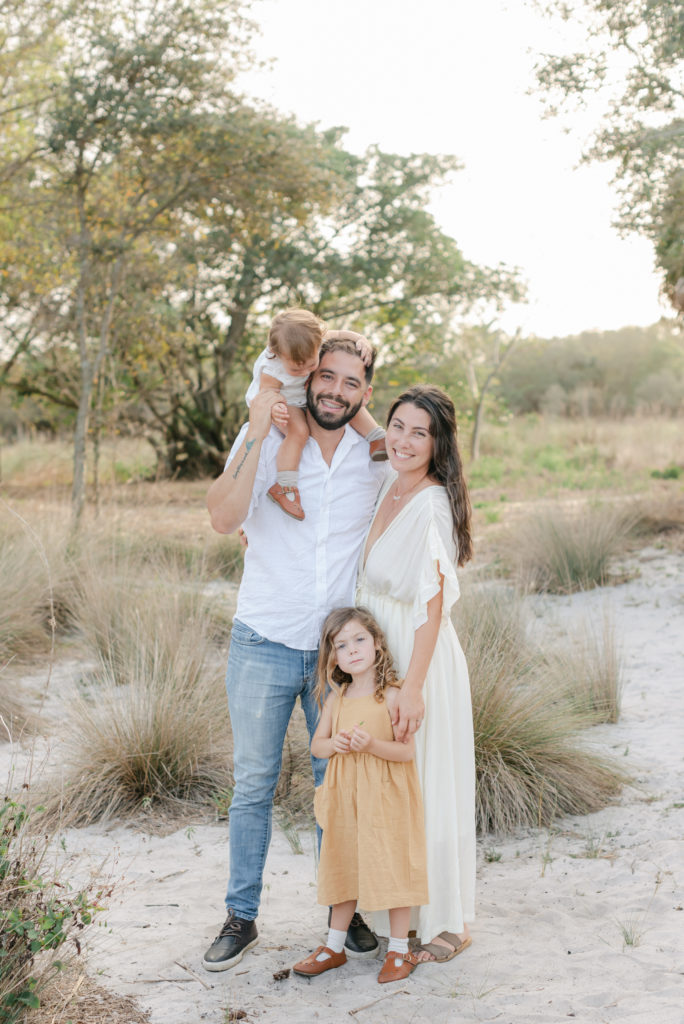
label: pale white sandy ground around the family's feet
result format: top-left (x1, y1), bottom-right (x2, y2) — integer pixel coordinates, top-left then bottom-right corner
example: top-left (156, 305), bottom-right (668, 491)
top-left (5, 549), bottom-right (684, 1024)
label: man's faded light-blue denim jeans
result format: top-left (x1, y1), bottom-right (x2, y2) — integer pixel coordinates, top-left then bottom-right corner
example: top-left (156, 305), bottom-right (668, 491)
top-left (225, 618), bottom-right (327, 921)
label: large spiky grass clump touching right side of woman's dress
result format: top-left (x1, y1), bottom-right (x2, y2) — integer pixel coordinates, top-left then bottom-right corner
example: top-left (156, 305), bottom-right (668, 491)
top-left (457, 587), bottom-right (625, 833)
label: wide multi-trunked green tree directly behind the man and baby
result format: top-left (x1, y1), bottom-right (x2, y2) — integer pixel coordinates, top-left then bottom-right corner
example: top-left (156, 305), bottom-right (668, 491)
top-left (124, 144), bottom-right (522, 474)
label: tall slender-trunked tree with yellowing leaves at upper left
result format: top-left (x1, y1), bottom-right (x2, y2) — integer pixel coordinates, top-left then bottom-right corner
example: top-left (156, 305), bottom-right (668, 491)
top-left (2, 0), bottom-right (335, 522)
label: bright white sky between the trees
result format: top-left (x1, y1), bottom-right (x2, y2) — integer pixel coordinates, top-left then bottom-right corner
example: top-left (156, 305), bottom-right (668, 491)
top-left (243, 0), bottom-right (672, 337)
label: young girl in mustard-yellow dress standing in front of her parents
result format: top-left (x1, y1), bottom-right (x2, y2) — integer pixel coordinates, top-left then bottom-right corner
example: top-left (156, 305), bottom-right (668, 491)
top-left (293, 608), bottom-right (428, 984)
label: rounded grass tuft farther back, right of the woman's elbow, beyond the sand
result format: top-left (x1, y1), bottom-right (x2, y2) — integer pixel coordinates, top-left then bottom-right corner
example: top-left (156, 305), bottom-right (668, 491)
top-left (508, 506), bottom-right (634, 594)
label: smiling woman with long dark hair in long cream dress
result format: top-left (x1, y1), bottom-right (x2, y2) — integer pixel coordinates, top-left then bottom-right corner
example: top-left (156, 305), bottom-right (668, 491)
top-left (356, 384), bottom-right (475, 963)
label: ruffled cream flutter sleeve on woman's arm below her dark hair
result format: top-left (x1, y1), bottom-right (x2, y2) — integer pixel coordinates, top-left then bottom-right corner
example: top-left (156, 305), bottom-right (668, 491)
top-left (412, 487), bottom-right (461, 630)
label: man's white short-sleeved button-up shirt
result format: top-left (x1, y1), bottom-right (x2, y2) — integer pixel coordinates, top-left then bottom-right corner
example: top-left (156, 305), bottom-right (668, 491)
top-left (227, 425), bottom-right (387, 650)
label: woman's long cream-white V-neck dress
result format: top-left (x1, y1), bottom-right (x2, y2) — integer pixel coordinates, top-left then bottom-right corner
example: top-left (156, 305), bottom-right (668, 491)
top-left (356, 477), bottom-right (475, 942)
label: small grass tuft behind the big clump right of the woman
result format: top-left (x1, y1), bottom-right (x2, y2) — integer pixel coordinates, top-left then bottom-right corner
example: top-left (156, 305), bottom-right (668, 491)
top-left (545, 613), bottom-right (624, 724)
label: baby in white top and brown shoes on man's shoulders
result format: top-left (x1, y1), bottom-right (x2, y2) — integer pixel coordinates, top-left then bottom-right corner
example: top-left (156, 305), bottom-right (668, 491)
top-left (245, 309), bottom-right (387, 519)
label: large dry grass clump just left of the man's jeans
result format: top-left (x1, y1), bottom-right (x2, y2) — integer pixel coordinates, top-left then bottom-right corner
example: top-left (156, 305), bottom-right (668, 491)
top-left (44, 628), bottom-right (230, 824)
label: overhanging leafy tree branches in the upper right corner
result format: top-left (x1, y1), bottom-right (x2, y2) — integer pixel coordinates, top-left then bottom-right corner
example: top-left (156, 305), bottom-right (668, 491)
top-left (537, 0), bottom-right (684, 300)
